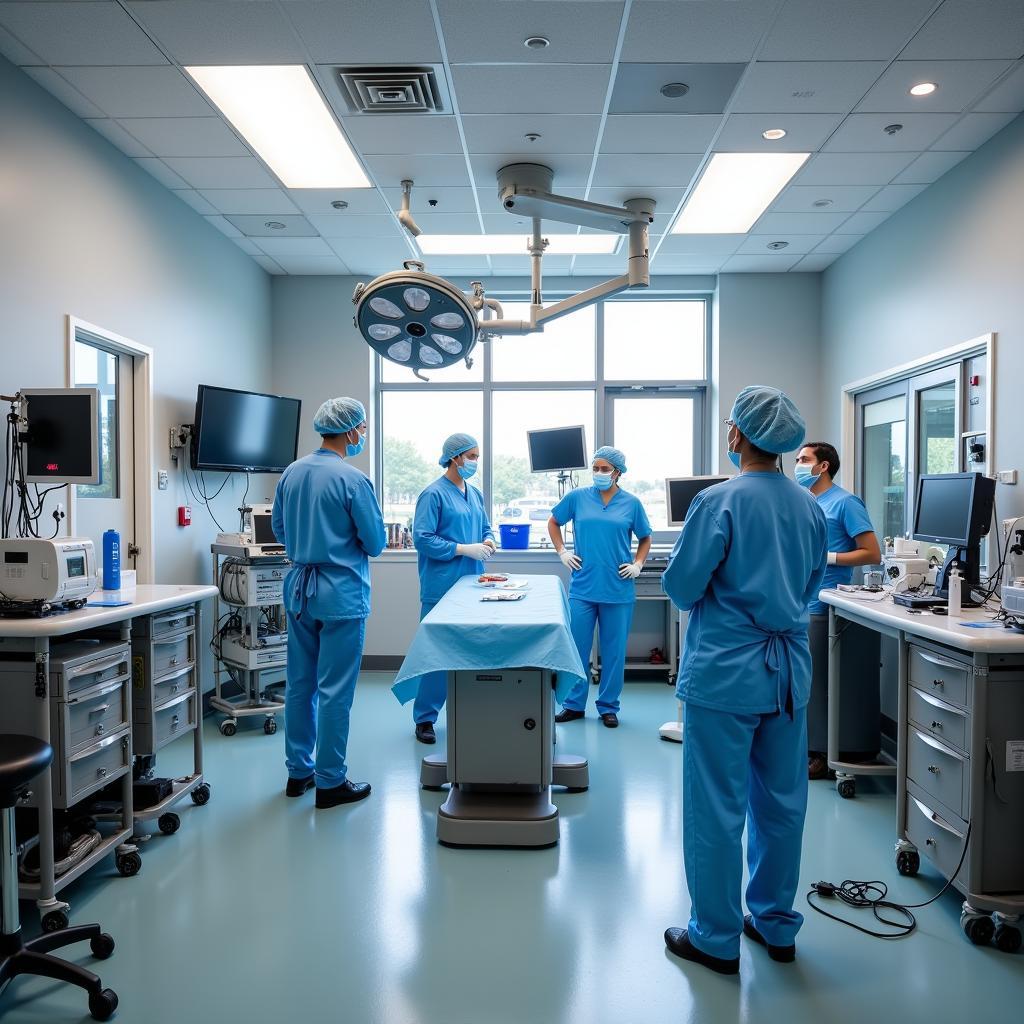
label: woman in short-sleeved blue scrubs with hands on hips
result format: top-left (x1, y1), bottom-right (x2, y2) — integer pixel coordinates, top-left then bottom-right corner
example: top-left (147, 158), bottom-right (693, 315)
top-left (548, 445), bottom-right (650, 729)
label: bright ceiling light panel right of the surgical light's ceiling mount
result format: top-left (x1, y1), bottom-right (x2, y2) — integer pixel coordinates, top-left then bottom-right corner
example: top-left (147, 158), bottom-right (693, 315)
top-left (672, 153), bottom-right (810, 234)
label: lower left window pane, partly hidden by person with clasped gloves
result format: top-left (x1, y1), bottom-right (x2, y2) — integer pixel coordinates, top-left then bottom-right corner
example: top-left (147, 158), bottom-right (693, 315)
top-left (381, 388), bottom-right (483, 525)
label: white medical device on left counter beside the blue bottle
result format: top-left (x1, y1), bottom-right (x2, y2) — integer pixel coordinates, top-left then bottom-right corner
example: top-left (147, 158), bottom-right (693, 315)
top-left (0, 537), bottom-right (96, 613)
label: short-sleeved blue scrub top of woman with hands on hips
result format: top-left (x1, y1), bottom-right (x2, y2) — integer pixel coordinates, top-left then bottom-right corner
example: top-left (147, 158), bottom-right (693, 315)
top-left (551, 486), bottom-right (650, 604)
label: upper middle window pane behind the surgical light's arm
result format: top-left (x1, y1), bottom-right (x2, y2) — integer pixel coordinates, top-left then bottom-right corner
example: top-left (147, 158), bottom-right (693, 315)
top-left (487, 302), bottom-right (595, 382)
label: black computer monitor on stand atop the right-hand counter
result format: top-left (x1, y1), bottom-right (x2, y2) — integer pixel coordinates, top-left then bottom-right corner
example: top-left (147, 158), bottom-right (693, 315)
top-left (912, 473), bottom-right (995, 597)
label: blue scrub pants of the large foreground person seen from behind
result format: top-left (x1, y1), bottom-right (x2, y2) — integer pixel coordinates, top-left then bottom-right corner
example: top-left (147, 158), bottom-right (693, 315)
top-left (683, 703), bottom-right (807, 959)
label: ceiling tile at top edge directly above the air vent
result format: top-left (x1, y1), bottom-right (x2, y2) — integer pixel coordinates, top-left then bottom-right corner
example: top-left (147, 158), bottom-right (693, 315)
top-left (282, 0), bottom-right (441, 66)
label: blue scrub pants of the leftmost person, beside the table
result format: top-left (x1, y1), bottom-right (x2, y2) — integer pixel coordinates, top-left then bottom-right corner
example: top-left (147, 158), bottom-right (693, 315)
top-left (285, 611), bottom-right (367, 788)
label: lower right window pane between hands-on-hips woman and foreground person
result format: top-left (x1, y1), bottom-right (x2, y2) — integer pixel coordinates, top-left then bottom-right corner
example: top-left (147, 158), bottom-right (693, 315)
top-left (613, 397), bottom-right (698, 529)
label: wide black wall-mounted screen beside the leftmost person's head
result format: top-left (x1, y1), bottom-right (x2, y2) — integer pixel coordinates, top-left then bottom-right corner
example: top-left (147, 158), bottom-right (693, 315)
top-left (191, 384), bottom-right (302, 473)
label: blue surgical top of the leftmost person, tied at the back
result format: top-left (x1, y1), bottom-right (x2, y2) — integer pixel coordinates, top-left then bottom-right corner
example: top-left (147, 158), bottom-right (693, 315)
top-left (271, 449), bottom-right (387, 621)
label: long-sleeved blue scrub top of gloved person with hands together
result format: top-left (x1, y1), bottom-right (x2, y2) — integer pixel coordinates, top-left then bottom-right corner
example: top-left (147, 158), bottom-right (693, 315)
top-left (413, 476), bottom-right (495, 604)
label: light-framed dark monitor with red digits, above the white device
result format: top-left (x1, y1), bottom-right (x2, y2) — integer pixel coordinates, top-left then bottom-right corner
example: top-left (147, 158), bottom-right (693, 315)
top-left (20, 387), bottom-right (100, 484)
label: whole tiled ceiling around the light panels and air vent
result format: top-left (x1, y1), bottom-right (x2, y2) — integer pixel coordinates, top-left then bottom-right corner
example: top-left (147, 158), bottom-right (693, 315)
top-left (0, 0), bottom-right (1024, 276)
